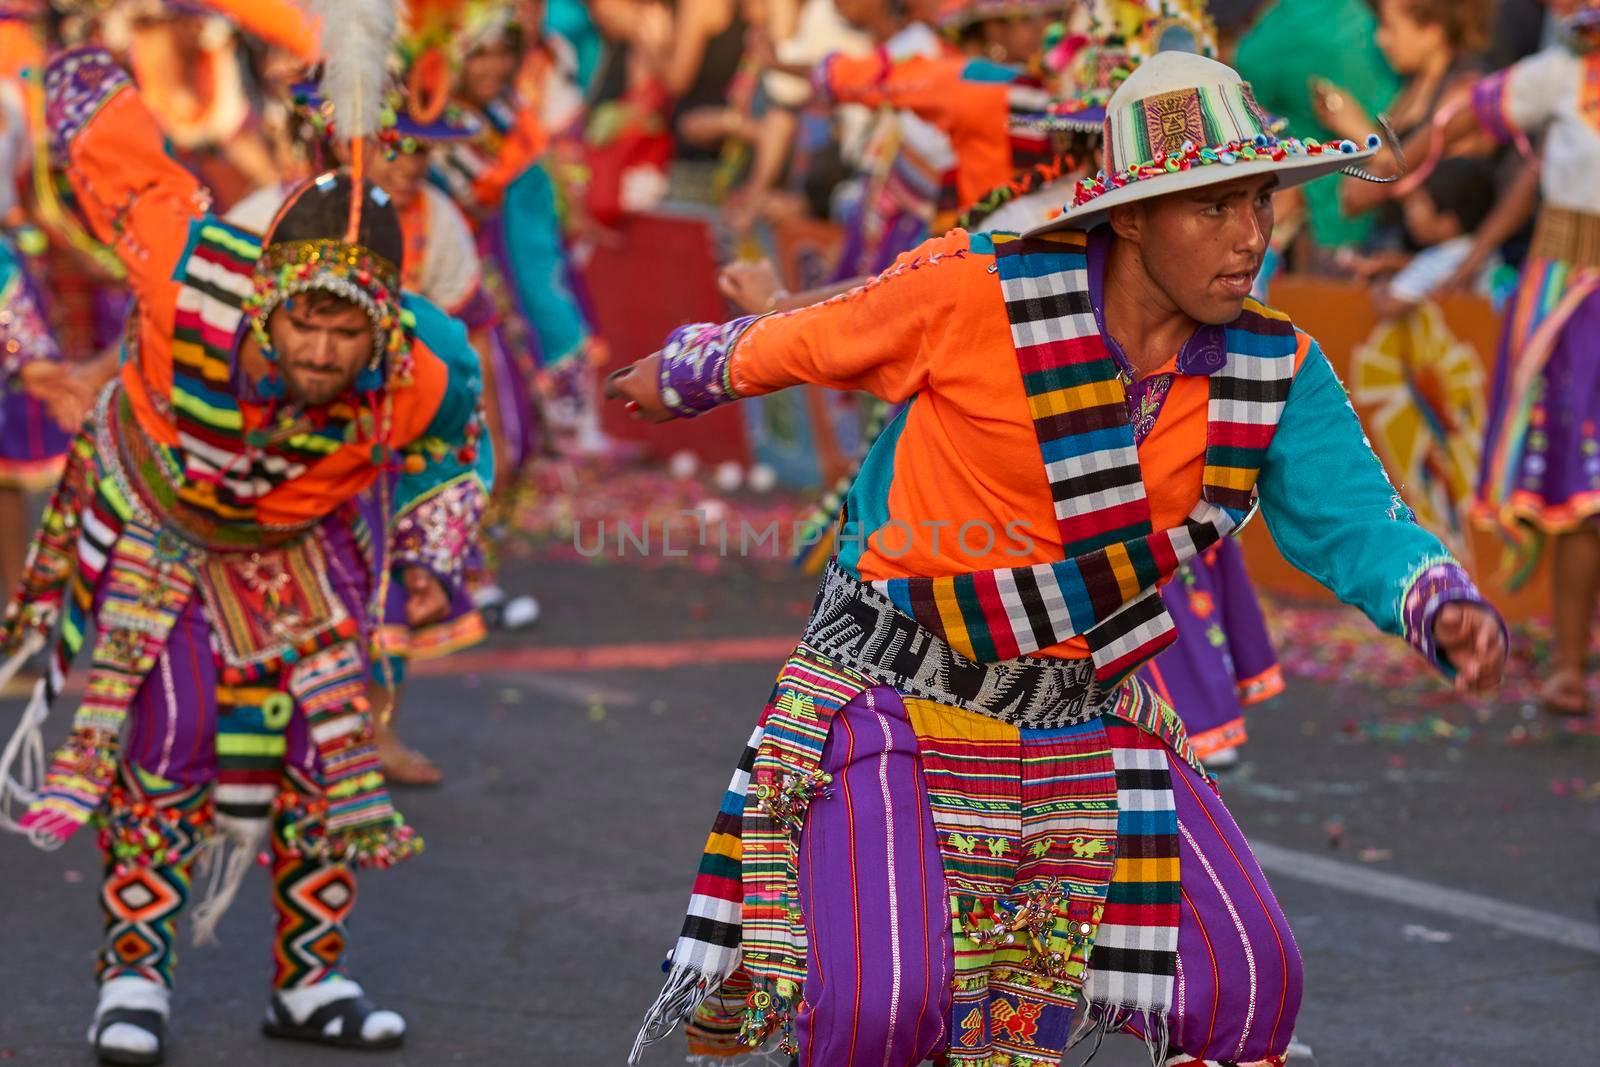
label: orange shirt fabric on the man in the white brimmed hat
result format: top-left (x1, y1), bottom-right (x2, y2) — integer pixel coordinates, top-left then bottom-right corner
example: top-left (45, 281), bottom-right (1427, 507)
top-left (730, 230), bottom-right (1309, 657)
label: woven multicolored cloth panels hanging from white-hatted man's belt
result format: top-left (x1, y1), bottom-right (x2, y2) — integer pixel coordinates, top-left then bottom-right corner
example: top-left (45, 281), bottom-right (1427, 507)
top-left (653, 646), bottom-right (1194, 1064)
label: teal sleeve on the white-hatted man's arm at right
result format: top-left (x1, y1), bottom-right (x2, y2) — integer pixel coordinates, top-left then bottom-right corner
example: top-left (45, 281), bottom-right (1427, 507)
top-left (1258, 342), bottom-right (1451, 633)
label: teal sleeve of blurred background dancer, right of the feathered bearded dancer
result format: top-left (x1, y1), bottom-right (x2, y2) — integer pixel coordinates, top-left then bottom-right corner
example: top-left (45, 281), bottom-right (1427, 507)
top-left (501, 163), bottom-right (589, 370)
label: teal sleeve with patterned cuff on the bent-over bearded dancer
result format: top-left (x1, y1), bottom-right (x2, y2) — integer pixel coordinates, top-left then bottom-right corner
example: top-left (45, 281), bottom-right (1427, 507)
top-left (389, 293), bottom-right (494, 585)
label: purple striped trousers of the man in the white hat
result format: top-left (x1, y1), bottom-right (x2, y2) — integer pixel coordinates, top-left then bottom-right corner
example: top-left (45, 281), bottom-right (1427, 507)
top-left (795, 688), bottom-right (1302, 1067)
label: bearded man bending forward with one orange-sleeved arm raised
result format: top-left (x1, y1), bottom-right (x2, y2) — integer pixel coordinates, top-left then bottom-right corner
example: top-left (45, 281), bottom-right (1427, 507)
top-left (0, 37), bottom-right (491, 1064)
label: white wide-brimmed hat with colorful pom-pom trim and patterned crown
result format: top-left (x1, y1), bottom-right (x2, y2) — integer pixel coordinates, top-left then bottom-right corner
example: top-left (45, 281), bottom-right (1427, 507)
top-left (1029, 51), bottom-right (1381, 235)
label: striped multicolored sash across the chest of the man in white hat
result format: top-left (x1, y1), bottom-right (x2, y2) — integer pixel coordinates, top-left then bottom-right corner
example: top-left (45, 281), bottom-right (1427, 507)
top-left (872, 232), bottom-right (1298, 683)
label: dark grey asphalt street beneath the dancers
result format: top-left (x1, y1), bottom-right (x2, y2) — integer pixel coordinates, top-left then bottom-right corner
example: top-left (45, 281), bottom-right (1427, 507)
top-left (0, 563), bottom-right (1600, 1067)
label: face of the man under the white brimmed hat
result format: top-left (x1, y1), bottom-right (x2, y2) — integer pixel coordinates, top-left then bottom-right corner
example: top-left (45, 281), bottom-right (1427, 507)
top-left (1112, 174), bottom-right (1278, 326)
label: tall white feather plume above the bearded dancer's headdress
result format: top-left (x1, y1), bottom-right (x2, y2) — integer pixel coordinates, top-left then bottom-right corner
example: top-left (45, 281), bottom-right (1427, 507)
top-left (309, 0), bottom-right (397, 141)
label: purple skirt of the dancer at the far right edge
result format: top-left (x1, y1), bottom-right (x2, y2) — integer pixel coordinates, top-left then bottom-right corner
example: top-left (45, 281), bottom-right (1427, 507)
top-left (1478, 279), bottom-right (1600, 515)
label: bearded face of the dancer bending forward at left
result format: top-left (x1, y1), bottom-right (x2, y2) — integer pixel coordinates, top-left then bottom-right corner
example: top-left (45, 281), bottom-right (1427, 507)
top-left (267, 293), bottom-right (373, 406)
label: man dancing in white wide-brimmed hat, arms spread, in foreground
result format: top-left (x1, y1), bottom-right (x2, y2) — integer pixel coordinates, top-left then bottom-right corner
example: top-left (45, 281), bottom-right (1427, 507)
top-left (610, 53), bottom-right (1506, 1067)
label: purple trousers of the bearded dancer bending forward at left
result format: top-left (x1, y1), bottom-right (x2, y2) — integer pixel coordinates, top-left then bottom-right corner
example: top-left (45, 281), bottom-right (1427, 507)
top-left (119, 518), bottom-right (371, 785)
